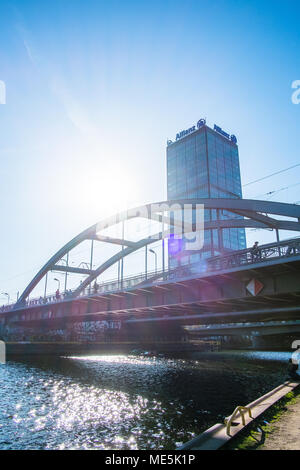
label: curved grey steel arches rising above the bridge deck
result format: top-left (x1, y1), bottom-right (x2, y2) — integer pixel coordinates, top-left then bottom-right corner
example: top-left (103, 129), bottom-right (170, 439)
top-left (15, 198), bottom-right (300, 307)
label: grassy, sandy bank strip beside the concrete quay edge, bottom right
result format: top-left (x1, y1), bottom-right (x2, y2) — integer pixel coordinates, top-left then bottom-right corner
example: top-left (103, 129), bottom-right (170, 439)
top-left (222, 387), bottom-right (300, 450)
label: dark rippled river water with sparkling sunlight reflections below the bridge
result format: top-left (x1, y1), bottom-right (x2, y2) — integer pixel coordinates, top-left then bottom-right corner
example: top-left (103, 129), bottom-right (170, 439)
top-left (0, 352), bottom-right (290, 449)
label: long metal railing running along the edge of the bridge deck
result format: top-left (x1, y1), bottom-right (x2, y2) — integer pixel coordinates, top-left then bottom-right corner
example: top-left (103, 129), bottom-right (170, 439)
top-left (4, 238), bottom-right (300, 313)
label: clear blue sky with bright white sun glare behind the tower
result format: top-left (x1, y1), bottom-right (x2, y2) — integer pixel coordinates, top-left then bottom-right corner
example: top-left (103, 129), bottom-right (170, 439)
top-left (0, 0), bottom-right (300, 304)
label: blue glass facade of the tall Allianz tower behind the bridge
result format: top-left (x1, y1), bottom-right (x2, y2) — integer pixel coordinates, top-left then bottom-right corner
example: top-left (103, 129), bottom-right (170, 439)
top-left (167, 125), bottom-right (246, 268)
